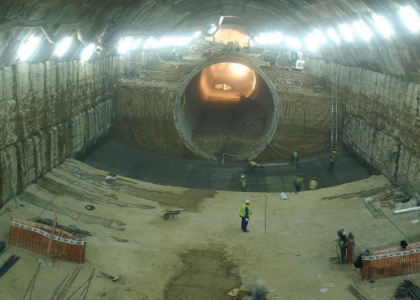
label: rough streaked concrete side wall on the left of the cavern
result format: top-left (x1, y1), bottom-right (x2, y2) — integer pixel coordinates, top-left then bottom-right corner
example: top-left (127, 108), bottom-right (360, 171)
top-left (0, 59), bottom-right (115, 203)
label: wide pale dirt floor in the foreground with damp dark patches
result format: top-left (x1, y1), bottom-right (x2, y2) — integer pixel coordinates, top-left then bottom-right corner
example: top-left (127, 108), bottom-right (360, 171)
top-left (0, 160), bottom-right (420, 300)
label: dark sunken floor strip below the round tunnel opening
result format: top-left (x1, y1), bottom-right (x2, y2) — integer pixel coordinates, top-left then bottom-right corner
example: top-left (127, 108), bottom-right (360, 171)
top-left (83, 141), bottom-right (370, 192)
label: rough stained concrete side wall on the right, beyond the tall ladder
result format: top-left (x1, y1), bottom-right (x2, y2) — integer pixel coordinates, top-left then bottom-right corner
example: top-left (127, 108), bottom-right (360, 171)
top-left (306, 60), bottom-right (420, 191)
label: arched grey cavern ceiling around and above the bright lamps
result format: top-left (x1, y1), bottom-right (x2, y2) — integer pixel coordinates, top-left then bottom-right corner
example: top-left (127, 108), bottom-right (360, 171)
top-left (0, 0), bottom-right (419, 78)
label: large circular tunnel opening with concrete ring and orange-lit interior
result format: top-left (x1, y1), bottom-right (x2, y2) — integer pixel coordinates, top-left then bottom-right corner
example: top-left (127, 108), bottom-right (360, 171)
top-left (175, 55), bottom-right (279, 160)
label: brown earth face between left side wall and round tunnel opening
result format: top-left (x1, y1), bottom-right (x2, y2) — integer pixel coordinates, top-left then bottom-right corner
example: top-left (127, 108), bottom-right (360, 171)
top-left (112, 83), bottom-right (190, 156)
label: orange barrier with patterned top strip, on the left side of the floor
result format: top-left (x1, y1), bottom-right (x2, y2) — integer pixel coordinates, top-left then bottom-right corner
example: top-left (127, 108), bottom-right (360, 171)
top-left (9, 218), bottom-right (86, 263)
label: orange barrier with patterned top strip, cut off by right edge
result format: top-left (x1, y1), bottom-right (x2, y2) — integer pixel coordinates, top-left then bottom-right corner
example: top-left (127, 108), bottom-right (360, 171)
top-left (360, 242), bottom-right (420, 279)
